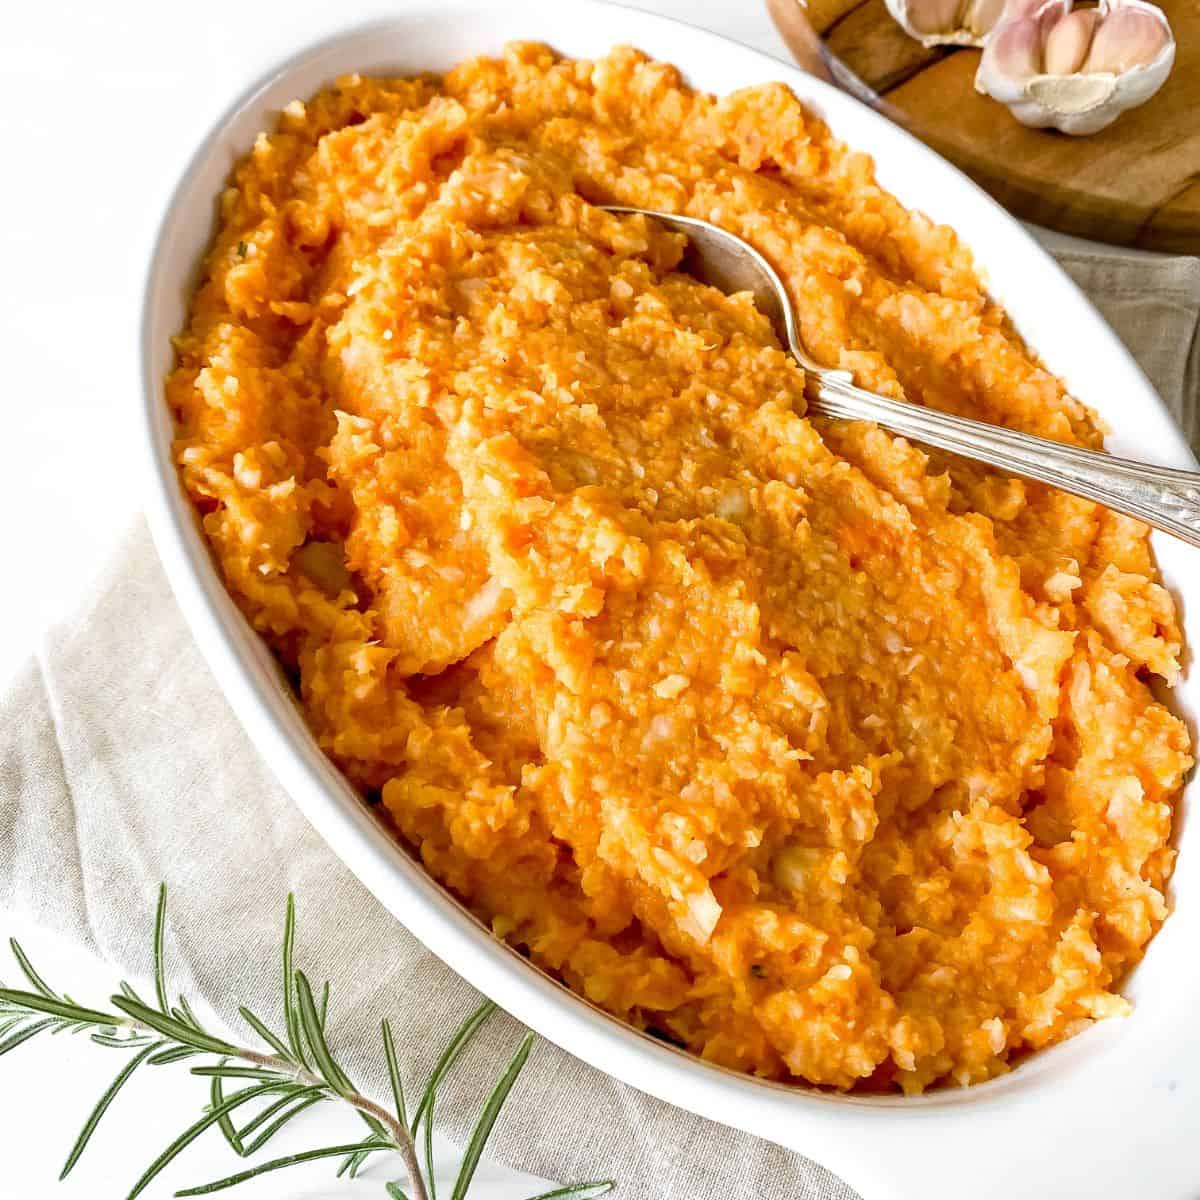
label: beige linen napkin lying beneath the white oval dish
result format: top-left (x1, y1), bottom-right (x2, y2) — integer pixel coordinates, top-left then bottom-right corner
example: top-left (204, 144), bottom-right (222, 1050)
top-left (0, 246), bottom-right (1200, 1200)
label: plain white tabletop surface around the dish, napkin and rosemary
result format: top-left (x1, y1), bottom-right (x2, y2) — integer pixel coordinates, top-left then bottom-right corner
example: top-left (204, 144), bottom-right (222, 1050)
top-left (0, 0), bottom-right (1142, 1200)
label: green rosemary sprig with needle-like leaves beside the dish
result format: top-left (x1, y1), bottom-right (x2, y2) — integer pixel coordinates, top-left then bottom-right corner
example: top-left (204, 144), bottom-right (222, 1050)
top-left (0, 887), bottom-right (613, 1200)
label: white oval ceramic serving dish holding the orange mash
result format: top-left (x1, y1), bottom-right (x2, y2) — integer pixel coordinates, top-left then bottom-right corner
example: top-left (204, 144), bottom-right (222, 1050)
top-left (140, 0), bottom-right (1200, 1200)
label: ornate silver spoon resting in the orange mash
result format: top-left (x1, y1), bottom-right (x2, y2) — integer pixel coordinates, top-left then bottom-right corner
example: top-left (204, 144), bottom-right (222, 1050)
top-left (607, 205), bottom-right (1200, 546)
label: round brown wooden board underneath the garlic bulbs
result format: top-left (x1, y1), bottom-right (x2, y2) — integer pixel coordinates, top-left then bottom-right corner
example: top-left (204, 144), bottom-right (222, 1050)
top-left (768, 0), bottom-right (1200, 254)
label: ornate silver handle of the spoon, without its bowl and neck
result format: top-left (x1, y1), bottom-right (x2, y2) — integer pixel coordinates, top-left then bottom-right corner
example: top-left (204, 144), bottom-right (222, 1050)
top-left (809, 372), bottom-right (1200, 546)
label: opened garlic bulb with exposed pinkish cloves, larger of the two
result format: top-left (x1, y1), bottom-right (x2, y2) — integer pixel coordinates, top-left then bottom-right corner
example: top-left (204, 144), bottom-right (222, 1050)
top-left (976, 0), bottom-right (1175, 134)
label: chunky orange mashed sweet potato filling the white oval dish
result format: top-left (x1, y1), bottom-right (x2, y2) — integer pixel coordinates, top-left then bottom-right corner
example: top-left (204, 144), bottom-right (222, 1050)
top-left (167, 44), bottom-right (1190, 1092)
